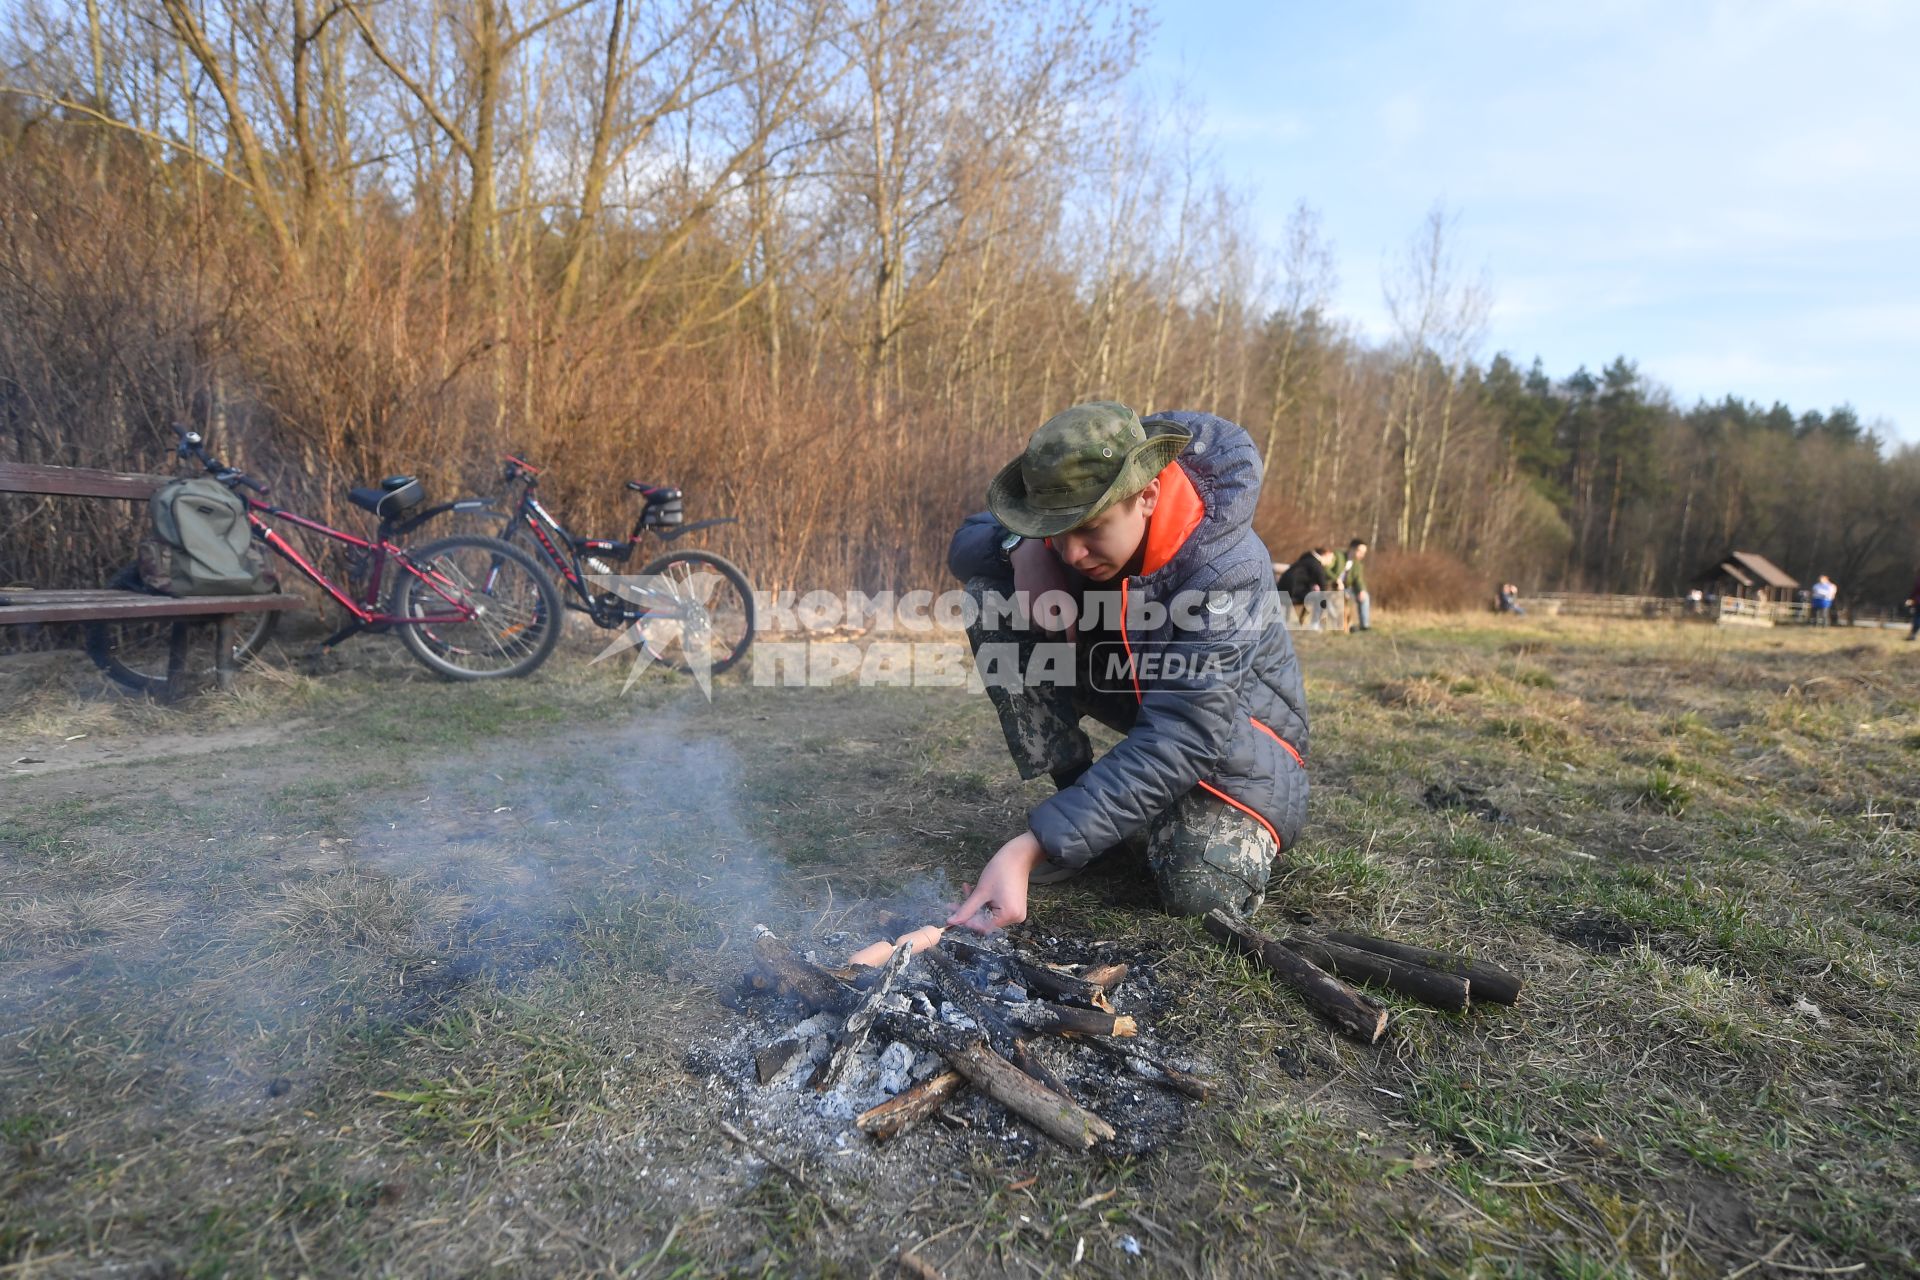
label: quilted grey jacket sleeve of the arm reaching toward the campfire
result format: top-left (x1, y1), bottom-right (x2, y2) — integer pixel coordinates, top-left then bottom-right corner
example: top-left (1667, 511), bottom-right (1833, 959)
top-left (1027, 583), bottom-right (1267, 867)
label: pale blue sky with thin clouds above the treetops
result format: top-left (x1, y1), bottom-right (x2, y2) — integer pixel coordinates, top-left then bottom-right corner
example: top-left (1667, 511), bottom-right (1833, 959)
top-left (1148, 0), bottom-right (1920, 441)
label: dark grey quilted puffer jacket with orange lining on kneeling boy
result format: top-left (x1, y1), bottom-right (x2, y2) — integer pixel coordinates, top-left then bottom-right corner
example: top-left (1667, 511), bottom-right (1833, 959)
top-left (947, 413), bottom-right (1308, 865)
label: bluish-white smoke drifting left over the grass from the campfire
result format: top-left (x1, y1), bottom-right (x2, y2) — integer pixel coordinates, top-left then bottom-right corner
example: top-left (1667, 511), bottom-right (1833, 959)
top-left (0, 700), bottom-right (952, 1128)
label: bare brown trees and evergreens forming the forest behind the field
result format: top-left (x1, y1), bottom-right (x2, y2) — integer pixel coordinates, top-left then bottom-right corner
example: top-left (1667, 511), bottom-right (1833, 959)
top-left (0, 0), bottom-right (1920, 604)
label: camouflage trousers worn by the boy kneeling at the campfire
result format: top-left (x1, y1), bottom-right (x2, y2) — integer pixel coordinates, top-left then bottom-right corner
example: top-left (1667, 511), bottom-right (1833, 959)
top-left (966, 578), bottom-right (1279, 917)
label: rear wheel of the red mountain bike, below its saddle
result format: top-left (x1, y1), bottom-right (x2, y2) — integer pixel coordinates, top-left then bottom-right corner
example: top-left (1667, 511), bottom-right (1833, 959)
top-left (392, 533), bottom-right (561, 679)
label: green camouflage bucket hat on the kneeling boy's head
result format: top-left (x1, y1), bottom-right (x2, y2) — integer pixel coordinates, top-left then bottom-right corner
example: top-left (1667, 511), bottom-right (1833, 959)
top-left (987, 401), bottom-right (1192, 537)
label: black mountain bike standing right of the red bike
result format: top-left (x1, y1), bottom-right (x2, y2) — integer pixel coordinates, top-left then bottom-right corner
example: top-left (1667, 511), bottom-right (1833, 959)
top-left (445, 455), bottom-right (753, 676)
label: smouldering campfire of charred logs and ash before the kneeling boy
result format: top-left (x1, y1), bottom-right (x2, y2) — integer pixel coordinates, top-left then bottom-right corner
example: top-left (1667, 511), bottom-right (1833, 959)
top-left (745, 927), bottom-right (1215, 1151)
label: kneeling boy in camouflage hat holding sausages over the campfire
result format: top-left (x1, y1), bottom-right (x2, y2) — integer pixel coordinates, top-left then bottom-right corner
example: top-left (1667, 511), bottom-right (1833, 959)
top-left (947, 401), bottom-right (1308, 933)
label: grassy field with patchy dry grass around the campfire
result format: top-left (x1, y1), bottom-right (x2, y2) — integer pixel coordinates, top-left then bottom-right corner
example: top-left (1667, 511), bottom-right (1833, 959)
top-left (0, 620), bottom-right (1920, 1280)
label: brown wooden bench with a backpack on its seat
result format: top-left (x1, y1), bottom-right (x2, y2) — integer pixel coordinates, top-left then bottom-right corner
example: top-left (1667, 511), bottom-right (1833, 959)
top-left (0, 462), bottom-right (301, 699)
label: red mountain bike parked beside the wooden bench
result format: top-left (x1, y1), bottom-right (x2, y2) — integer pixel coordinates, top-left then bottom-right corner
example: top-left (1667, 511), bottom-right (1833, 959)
top-left (86, 426), bottom-right (561, 693)
